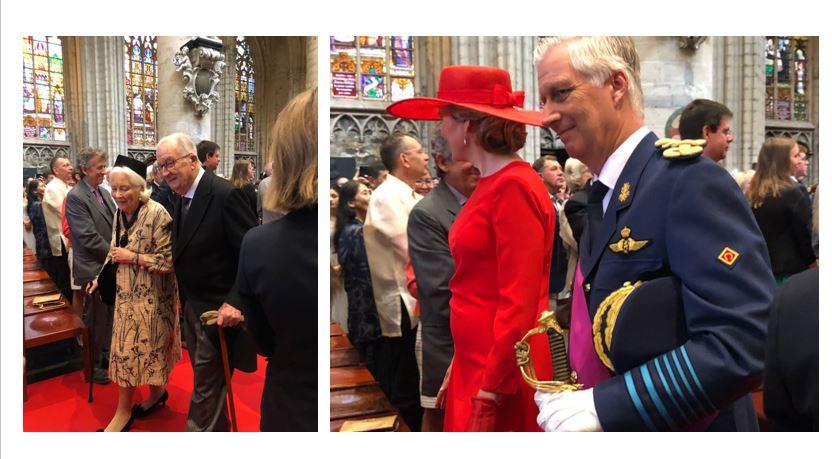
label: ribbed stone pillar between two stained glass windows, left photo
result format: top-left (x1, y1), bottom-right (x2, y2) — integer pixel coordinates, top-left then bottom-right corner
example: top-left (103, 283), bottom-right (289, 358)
top-left (64, 36), bottom-right (127, 164)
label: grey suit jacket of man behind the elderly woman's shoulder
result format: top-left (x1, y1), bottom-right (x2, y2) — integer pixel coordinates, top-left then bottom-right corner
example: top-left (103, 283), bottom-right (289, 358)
top-left (66, 181), bottom-right (116, 286)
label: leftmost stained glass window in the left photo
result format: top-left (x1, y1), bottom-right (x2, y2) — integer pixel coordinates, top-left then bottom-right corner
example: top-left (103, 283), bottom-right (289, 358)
top-left (23, 35), bottom-right (67, 141)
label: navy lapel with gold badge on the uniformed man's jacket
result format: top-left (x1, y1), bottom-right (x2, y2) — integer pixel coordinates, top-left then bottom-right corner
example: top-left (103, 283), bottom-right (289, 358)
top-left (581, 132), bottom-right (658, 278)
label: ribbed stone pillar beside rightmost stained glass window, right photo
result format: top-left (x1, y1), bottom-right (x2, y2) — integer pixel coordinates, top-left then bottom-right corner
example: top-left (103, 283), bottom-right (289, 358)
top-left (713, 37), bottom-right (765, 171)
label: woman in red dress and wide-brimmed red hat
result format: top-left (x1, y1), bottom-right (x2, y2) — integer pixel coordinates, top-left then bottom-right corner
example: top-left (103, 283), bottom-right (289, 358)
top-left (387, 66), bottom-right (555, 431)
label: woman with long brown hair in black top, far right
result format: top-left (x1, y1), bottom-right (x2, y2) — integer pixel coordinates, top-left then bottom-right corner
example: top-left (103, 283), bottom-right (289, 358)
top-left (746, 137), bottom-right (817, 285)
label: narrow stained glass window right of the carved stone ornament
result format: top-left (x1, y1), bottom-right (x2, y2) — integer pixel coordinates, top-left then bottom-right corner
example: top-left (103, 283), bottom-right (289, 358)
top-left (234, 37), bottom-right (255, 151)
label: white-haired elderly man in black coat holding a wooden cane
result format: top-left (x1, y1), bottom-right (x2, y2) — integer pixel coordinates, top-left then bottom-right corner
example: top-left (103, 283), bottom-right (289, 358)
top-left (156, 133), bottom-right (257, 431)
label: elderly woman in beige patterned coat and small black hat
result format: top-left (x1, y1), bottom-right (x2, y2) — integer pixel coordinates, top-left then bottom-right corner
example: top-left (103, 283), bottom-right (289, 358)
top-left (89, 156), bottom-right (181, 432)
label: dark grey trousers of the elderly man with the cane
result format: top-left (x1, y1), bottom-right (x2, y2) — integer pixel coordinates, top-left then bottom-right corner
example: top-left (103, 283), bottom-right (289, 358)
top-left (183, 302), bottom-right (234, 432)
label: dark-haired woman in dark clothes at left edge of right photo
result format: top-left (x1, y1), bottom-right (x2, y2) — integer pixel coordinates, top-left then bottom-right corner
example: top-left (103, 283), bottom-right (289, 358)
top-left (335, 180), bottom-right (381, 374)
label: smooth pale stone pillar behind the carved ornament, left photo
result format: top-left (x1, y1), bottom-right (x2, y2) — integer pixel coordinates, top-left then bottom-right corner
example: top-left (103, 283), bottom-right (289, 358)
top-left (156, 37), bottom-right (213, 146)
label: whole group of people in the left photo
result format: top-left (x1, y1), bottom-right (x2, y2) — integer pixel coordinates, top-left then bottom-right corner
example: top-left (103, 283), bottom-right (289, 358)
top-left (24, 89), bottom-right (318, 431)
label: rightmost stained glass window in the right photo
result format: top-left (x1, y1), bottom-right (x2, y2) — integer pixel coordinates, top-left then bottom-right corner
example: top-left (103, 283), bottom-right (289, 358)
top-left (765, 37), bottom-right (809, 121)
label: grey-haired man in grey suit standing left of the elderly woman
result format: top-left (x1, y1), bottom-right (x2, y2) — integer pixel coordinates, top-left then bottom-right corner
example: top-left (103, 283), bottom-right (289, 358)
top-left (66, 147), bottom-right (116, 384)
